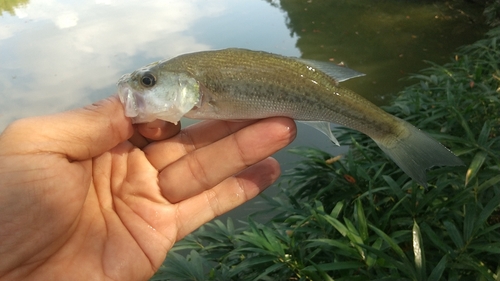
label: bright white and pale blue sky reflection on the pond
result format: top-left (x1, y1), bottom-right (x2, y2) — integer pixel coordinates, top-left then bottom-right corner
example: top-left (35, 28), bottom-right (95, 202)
top-left (0, 0), bottom-right (299, 130)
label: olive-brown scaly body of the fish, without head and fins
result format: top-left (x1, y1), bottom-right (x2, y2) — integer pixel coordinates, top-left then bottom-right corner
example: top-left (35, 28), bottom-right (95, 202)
top-left (162, 49), bottom-right (398, 140)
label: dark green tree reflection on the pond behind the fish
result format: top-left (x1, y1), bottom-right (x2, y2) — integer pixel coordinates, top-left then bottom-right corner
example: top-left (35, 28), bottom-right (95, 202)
top-left (271, 0), bottom-right (486, 104)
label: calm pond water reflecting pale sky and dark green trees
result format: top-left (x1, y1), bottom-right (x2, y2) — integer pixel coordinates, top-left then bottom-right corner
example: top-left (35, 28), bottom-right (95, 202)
top-left (0, 0), bottom-right (486, 215)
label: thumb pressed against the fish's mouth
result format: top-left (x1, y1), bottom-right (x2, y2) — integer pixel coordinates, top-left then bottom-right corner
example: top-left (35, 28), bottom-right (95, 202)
top-left (0, 96), bottom-right (133, 160)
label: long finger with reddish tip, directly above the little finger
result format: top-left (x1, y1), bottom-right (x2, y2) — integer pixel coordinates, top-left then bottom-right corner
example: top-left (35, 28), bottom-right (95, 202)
top-left (158, 118), bottom-right (296, 202)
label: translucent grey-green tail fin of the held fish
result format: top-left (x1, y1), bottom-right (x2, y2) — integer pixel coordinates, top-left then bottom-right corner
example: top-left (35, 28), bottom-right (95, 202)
top-left (374, 119), bottom-right (464, 187)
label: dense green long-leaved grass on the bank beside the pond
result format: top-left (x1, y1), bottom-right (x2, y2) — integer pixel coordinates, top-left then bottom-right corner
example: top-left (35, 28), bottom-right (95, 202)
top-left (152, 28), bottom-right (500, 280)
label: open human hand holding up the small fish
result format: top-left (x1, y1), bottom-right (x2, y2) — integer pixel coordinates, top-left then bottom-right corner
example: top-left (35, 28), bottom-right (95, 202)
top-left (0, 97), bottom-right (296, 280)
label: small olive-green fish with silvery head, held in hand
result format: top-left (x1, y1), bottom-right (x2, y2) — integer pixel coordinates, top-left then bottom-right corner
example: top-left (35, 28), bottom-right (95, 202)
top-left (117, 48), bottom-right (463, 187)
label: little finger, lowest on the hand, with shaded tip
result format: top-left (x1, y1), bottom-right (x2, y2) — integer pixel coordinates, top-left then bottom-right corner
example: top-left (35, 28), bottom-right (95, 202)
top-left (175, 155), bottom-right (280, 240)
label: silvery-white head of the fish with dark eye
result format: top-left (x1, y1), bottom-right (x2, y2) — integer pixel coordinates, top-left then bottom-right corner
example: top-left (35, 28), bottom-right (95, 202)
top-left (118, 63), bottom-right (200, 124)
